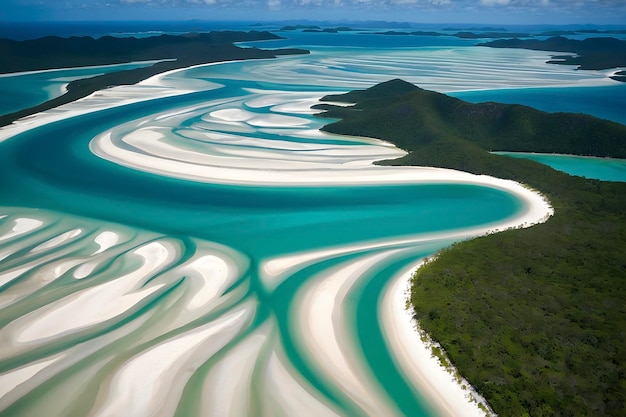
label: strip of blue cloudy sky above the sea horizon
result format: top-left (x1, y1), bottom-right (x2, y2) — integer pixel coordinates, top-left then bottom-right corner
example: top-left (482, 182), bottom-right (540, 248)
top-left (0, 0), bottom-right (626, 25)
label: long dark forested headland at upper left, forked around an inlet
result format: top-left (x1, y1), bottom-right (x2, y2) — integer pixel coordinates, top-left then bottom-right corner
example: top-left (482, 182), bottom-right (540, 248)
top-left (0, 31), bottom-right (309, 126)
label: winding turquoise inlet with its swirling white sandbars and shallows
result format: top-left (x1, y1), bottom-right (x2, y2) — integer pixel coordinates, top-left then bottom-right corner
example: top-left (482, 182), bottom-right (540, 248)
top-left (0, 29), bottom-right (612, 416)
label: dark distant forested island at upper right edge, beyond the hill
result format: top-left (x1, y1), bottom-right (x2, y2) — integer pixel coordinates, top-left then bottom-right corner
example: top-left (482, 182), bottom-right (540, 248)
top-left (478, 36), bottom-right (626, 82)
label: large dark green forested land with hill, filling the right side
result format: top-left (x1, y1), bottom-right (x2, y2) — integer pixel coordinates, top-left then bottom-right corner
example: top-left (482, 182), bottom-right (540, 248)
top-left (318, 80), bottom-right (626, 417)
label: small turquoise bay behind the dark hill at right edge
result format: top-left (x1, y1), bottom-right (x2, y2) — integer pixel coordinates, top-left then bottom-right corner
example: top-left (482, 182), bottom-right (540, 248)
top-left (495, 152), bottom-right (626, 182)
